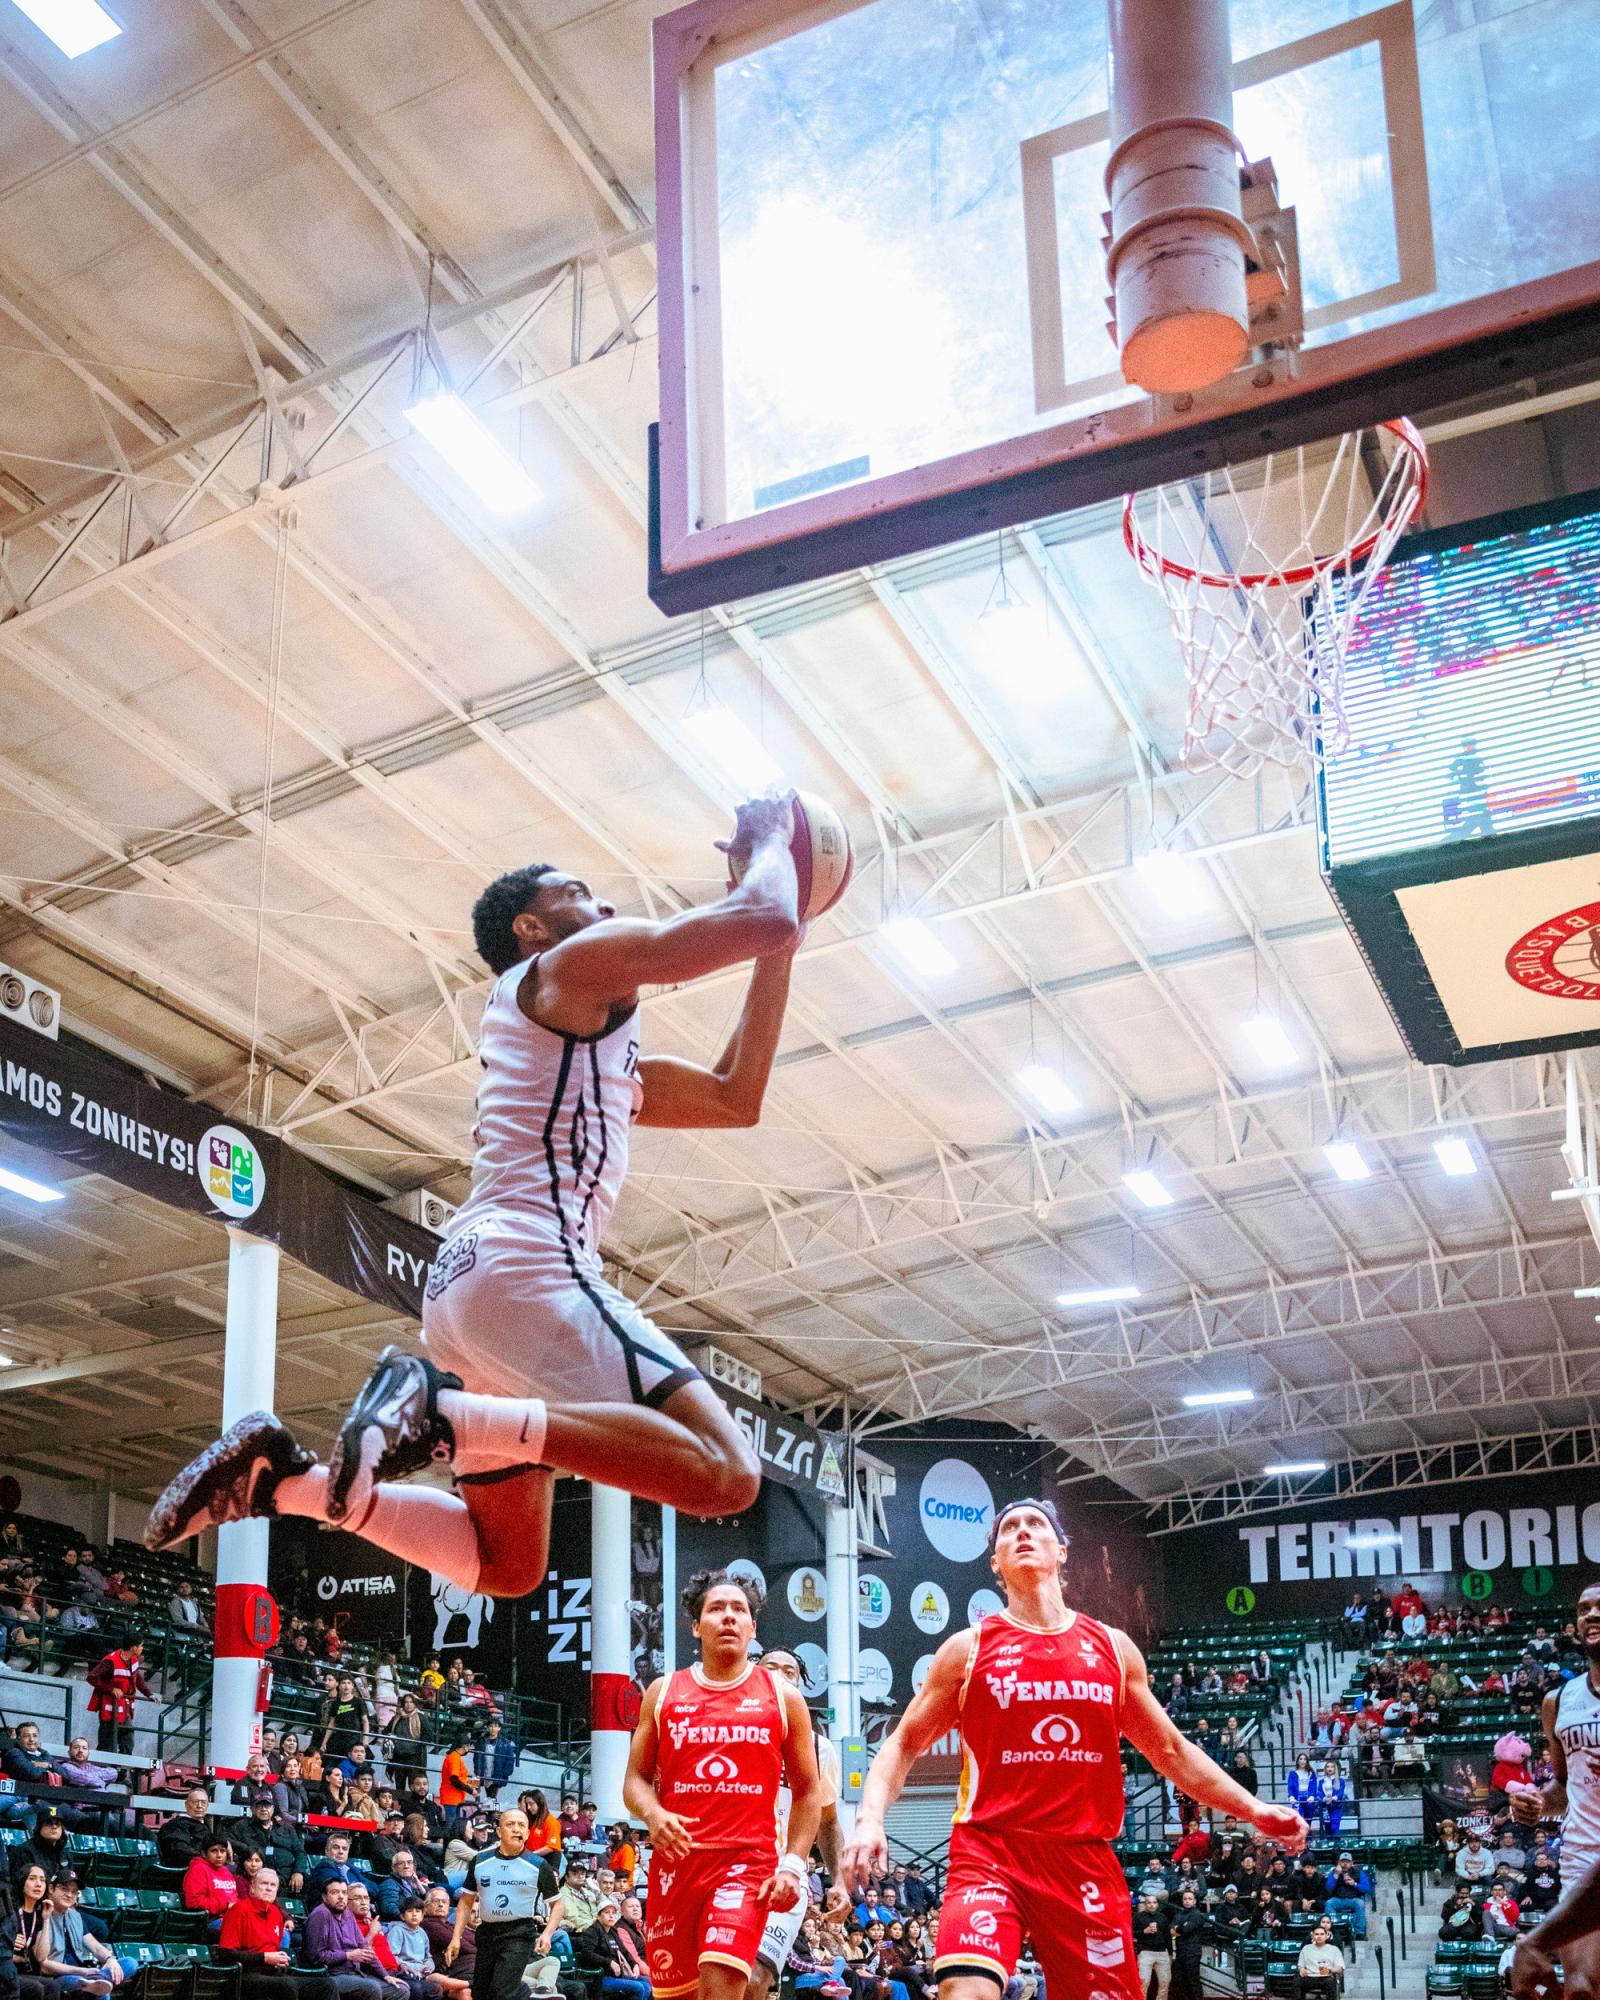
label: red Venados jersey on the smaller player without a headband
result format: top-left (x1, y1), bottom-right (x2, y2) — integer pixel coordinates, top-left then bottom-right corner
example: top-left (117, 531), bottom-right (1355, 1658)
top-left (656, 1662), bottom-right (788, 1856)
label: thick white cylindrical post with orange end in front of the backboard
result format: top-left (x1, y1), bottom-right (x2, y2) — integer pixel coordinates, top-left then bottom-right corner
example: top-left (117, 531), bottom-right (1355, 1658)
top-left (1106, 0), bottom-right (1254, 394)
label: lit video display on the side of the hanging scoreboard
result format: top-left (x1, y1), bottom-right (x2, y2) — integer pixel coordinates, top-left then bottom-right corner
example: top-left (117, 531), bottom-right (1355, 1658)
top-left (1322, 496), bottom-right (1600, 866)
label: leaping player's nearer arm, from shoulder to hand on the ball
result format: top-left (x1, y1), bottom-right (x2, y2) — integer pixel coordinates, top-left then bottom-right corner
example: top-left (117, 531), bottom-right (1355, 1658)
top-left (538, 798), bottom-right (800, 1020)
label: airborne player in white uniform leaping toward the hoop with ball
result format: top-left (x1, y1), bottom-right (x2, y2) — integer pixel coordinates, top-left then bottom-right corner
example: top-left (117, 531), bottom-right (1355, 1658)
top-left (144, 798), bottom-right (800, 1596)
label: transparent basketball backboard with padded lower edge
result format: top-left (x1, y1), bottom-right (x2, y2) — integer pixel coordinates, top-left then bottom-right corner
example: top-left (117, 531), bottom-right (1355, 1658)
top-left (652, 0), bottom-right (1600, 610)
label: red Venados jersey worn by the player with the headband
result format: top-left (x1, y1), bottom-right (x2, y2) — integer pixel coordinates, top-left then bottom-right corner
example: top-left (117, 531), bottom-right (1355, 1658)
top-left (956, 1612), bottom-right (1124, 1840)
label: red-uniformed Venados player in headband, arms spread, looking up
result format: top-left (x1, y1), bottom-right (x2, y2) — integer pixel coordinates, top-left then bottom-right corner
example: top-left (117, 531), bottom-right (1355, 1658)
top-left (844, 1500), bottom-right (1306, 2000)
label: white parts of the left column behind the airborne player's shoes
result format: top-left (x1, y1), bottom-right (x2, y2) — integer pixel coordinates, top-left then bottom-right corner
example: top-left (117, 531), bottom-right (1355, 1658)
top-left (210, 1230), bottom-right (278, 1772)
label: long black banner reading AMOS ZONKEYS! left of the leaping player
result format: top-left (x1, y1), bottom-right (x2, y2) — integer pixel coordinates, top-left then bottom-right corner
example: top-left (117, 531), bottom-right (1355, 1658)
top-left (0, 1018), bottom-right (438, 1314)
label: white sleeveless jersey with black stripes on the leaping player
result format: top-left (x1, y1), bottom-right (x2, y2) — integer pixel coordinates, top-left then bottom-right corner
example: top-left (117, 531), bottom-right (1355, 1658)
top-left (450, 960), bottom-right (644, 1262)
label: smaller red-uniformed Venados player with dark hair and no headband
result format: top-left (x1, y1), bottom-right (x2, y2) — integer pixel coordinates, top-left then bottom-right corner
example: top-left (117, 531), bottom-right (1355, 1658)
top-left (622, 1570), bottom-right (822, 2000)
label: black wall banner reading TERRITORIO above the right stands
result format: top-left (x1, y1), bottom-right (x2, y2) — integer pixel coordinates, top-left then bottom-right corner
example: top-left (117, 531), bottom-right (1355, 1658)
top-left (1160, 1472), bottom-right (1600, 1624)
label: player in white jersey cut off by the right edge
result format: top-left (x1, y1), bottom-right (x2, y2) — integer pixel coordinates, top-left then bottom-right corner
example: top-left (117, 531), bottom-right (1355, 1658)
top-left (1508, 1584), bottom-right (1600, 2000)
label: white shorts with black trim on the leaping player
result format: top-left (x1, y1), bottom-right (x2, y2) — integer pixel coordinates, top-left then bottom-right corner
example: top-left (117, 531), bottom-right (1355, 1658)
top-left (422, 1208), bottom-right (700, 1410)
